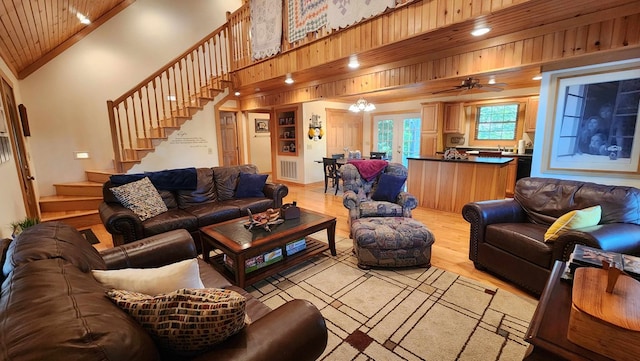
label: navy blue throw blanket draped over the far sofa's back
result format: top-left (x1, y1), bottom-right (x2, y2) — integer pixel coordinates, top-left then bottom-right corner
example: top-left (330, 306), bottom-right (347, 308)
top-left (109, 168), bottom-right (198, 191)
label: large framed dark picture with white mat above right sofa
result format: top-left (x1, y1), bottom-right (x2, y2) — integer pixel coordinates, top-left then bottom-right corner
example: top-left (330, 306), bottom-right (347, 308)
top-left (545, 63), bottom-right (640, 173)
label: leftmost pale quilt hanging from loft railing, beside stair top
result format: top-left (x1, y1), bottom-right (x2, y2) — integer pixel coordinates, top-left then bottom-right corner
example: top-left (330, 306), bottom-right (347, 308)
top-left (250, 0), bottom-right (282, 60)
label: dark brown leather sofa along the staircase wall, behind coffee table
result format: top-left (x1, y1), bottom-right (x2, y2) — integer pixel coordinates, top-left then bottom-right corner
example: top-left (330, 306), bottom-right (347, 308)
top-left (98, 164), bottom-right (289, 248)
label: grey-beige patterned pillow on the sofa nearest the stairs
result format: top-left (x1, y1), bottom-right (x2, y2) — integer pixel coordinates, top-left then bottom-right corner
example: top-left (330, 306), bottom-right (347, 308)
top-left (110, 177), bottom-right (167, 221)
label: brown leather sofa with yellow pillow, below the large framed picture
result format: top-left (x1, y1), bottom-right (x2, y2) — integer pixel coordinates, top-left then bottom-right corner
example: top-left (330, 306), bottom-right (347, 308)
top-left (462, 178), bottom-right (640, 296)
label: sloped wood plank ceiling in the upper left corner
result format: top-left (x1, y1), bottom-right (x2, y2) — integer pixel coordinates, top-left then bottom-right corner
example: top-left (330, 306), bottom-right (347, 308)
top-left (0, 0), bottom-right (135, 79)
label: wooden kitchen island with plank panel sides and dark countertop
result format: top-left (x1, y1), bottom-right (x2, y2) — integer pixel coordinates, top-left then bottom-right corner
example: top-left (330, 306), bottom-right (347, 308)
top-left (407, 156), bottom-right (514, 213)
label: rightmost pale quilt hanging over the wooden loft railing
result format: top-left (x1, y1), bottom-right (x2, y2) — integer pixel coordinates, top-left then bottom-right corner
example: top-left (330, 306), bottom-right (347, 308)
top-left (327, 0), bottom-right (396, 29)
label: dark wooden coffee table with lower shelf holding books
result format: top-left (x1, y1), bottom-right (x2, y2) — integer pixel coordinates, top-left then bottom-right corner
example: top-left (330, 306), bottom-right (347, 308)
top-left (200, 208), bottom-right (336, 288)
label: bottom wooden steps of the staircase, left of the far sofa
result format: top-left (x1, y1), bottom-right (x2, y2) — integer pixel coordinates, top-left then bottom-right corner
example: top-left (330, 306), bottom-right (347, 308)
top-left (38, 171), bottom-right (115, 229)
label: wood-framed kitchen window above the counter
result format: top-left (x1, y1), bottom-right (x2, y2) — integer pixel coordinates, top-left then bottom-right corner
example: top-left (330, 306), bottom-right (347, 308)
top-left (469, 102), bottom-right (524, 148)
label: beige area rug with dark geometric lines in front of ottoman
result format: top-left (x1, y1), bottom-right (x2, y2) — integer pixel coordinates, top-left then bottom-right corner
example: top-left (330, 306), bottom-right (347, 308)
top-left (247, 233), bottom-right (537, 361)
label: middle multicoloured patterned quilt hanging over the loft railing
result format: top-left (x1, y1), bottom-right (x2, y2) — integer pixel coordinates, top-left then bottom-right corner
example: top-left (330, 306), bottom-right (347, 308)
top-left (288, 0), bottom-right (331, 43)
